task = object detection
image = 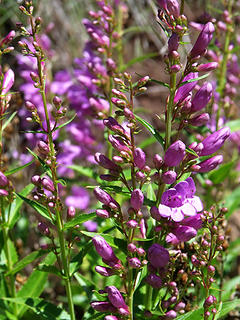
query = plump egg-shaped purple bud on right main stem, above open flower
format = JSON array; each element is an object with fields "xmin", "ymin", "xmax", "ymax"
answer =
[{"xmin": 164, "ymin": 140, "xmax": 186, "ymax": 167}]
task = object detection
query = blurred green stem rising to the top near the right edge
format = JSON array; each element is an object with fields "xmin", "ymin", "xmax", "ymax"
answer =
[{"xmin": 216, "ymin": 0, "xmax": 233, "ymax": 130}]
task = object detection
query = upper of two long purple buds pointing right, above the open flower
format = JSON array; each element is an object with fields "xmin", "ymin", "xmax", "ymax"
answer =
[{"xmin": 200, "ymin": 127, "xmax": 231, "ymax": 156}]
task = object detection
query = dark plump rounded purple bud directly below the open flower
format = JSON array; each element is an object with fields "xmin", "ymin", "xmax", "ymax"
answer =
[{"xmin": 148, "ymin": 243, "xmax": 169, "ymax": 268}]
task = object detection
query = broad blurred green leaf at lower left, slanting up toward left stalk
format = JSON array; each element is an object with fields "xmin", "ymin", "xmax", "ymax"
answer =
[{"xmin": 17, "ymin": 252, "xmax": 56, "ymax": 318}]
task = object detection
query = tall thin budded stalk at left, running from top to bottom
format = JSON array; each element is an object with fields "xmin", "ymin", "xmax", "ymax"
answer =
[{"xmin": 20, "ymin": 2, "xmax": 75, "ymax": 320}]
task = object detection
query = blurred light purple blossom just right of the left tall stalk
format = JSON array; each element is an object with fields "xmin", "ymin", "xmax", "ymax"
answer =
[{"xmin": 65, "ymin": 185, "xmax": 90, "ymax": 210}]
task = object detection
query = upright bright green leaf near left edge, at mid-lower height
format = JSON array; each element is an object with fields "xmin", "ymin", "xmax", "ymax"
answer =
[{"xmin": 6, "ymin": 183, "xmax": 34, "ymax": 229}]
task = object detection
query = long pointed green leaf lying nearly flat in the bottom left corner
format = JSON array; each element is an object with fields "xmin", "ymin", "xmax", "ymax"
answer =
[{"xmin": 2, "ymin": 297, "xmax": 70, "ymax": 320}]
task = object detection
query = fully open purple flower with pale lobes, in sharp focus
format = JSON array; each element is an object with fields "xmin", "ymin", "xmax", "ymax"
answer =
[{"xmin": 158, "ymin": 177, "xmax": 203, "ymax": 222}]
